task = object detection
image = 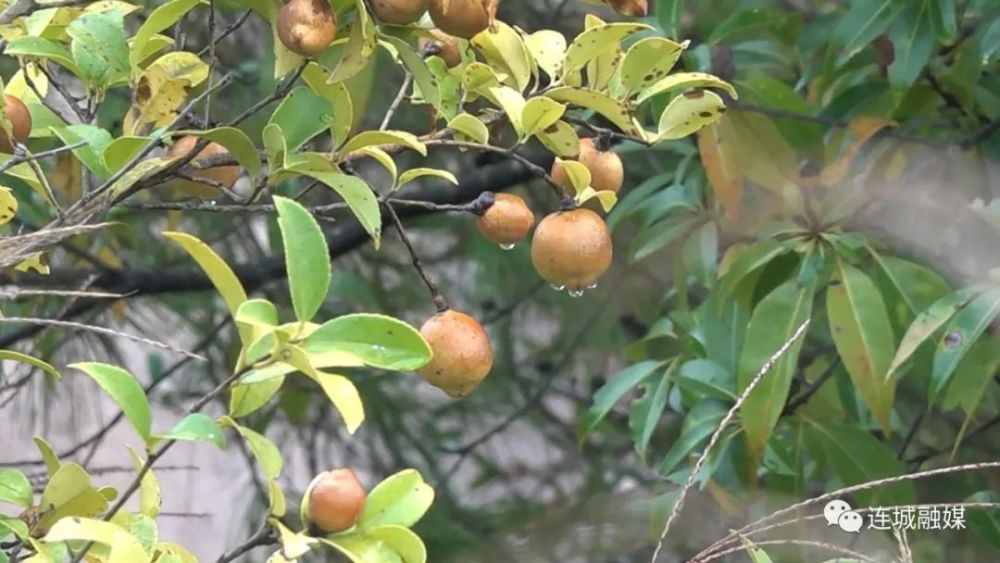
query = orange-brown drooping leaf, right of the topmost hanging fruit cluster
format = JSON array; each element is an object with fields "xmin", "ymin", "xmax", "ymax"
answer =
[{"xmin": 698, "ymin": 118, "xmax": 743, "ymax": 220}]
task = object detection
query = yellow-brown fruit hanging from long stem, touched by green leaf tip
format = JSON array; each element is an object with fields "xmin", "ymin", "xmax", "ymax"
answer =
[{"xmin": 419, "ymin": 310, "xmax": 493, "ymax": 399}]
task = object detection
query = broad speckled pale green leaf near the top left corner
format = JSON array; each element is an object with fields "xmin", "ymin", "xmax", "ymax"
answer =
[{"xmin": 66, "ymin": 12, "xmax": 130, "ymax": 90}]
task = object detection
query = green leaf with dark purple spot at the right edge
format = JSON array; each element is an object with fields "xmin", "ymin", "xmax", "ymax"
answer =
[{"xmin": 928, "ymin": 290, "xmax": 1000, "ymax": 404}]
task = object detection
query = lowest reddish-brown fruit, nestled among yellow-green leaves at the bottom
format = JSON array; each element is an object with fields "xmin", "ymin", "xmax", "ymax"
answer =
[{"xmin": 308, "ymin": 467, "xmax": 366, "ymax": 534}]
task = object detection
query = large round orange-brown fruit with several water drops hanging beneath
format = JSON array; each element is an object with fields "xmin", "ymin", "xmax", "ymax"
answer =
[{"xmin": 531, "ymin": 208, "xmax": 612, "ymax": 292}]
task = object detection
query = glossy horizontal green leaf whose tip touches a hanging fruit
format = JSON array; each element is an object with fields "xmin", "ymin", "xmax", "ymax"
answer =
[{"xmin": 303, "ymin": 313, "xmax": 431, "ymax": 371}]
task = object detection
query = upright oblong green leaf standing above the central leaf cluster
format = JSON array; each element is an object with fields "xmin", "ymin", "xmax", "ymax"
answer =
[{"xmin": 274, "ymin": 196, "xmax": 330, "ymax": 321}]
